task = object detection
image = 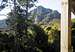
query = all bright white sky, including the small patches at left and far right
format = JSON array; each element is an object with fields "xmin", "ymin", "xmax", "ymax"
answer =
[{"xmin": 0, "ymin": 0, "xmax": 75, "ymax": 20}]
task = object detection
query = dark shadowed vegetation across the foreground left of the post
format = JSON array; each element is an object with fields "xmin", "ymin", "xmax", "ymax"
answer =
[{"xmin": 0, "ymin": 22, "xmax": 59, "ymax": 52}]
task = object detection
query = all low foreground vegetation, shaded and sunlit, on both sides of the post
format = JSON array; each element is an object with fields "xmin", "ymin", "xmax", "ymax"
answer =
[{"xmin": 0, "ymin": 18, "xmax": 75, "ymax": 52}]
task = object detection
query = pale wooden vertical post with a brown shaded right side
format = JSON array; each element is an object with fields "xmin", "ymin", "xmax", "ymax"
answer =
[{"xmin": 60, "ymin": 0, "xmax": 72, "ymax": 52}]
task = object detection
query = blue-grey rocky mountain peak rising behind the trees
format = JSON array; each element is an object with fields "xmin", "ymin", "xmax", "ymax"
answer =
[{"xmin": 30, "ymin": 6, "xmax": 61, "ymax": 23}]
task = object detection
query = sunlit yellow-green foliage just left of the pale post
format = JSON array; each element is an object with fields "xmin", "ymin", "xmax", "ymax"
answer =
[{"xmin": 44, "ymin": 22, "xmax": 59, "ymax": 43}]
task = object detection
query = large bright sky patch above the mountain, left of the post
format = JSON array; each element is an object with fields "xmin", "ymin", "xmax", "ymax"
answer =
[{"xmin": 37, "ymin": 0, "xmax": 61, "ymax": 12}]
